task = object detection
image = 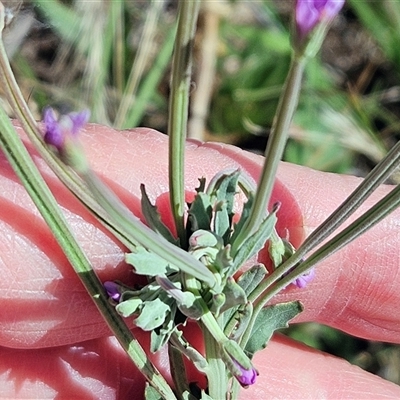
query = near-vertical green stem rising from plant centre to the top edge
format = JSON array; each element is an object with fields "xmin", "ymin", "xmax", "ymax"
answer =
[{"xmin": 168, "ymin": 0, "xmax": 200, "ymax": 246}]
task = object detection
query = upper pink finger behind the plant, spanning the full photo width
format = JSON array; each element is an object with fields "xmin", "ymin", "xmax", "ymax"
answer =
[{"xmin": 0, "ymin": 125, "xmax": 400, "ymax": 347}]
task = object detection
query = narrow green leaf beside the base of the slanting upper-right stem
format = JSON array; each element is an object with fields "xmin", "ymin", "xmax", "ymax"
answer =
[{"xmin": 230, "ymin": 213, "xmax": 277, "ymax": 275}]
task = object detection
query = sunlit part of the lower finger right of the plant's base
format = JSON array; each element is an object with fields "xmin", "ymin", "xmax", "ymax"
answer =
[{"xmin": 241, "ymin": 336, "xmax": 400, "ymax": 399}]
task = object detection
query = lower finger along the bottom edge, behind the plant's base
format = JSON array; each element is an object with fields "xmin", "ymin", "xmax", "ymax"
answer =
[{"xmin": 0, "ymin": 336, "xmax": 400, "ymax": 400}]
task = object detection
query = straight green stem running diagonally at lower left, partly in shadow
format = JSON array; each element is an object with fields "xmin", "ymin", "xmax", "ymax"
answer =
[{"xmin": 0, "ymin": 107, "xmax": 175, "ymax": 399}]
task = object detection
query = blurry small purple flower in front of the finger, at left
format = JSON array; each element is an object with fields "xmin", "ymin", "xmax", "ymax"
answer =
[{"xmin": 43, "ymin": 107, "xmax": 90, "ymax": 152}]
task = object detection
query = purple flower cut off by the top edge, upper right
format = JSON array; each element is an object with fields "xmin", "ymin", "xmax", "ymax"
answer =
[{"xmin": 296, "ymin": 0, "xmax": 345, "ymax": 42}]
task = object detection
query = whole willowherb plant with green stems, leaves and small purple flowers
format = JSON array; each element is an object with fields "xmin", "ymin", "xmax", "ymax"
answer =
[{"xmin": 0, "ymin": 0, "xmax": 400, "ymax": 400}]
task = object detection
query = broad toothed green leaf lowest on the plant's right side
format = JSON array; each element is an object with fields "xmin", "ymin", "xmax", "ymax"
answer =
[{"xmin": 245, "ymin": 301, "xmax": 303, "ymax": 358}]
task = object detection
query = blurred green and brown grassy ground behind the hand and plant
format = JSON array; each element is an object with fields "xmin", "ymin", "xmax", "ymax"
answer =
[{"xmin": 0, "ymin": 0, "xmax": 400, "ymax": 384}]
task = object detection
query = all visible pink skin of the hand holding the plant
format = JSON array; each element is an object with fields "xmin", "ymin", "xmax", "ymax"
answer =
[{"xmin": 0, "ymin": 125, "xmax": 400, "ymax": 399}]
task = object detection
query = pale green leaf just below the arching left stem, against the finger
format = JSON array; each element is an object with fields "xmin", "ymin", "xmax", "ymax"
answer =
[{"xmin": 125, "ymin": 246, "xmax": 177, "ymax": 276}]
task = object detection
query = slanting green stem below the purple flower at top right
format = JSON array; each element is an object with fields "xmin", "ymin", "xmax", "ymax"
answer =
[{"xmin": 232, "ymin": 57, "xmax": 306, "ymax": 255}]
